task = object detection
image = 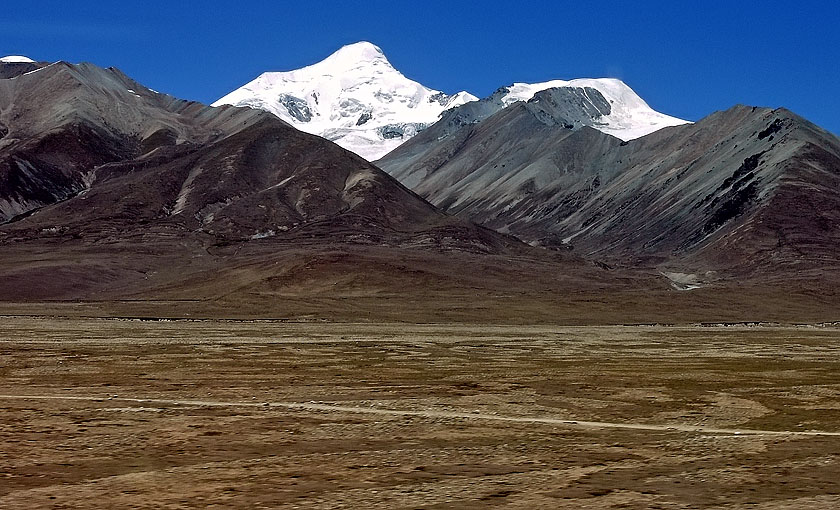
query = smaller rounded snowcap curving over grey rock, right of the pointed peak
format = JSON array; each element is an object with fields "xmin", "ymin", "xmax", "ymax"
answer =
[{"xmin": 502, "ymin": 78, "xmax": 689, "ymax": 141}]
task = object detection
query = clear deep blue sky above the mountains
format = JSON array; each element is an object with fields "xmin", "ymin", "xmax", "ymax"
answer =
[{"xmin": 0, "ymin": 0, "xmax": 840, "ymax": 133}]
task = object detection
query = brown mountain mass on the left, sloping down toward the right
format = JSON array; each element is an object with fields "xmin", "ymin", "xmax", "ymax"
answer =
[{"xmin": 0, "ymin": 57, "xmax": 624, "ymax": 306}]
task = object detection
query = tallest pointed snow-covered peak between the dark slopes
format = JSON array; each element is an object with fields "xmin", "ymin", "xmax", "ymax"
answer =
[{"xmin": 213, "ymin": 42, "xmax": 477, "ymax": 161}]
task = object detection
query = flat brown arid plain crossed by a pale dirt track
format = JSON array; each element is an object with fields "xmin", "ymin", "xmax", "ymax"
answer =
[{"xmin": 0, "ymin": 317, "xmax": 840, "ymax": 509}]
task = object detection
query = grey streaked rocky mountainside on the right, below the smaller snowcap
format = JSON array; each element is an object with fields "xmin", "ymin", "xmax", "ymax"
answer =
[{"xmin": 378, "ymin": 88, "xmax": 840, "ymax": 278}]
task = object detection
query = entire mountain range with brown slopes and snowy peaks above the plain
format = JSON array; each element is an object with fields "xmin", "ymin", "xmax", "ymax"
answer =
[{"xmin": 0, "ymin": 43, "xmax": 840, "ymax": 322}]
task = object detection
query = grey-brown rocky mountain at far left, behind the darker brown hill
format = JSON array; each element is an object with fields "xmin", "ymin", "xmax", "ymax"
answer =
[{"xmin": 0, "ymin": 62, "xmax": 266, "ymax": 221}]
